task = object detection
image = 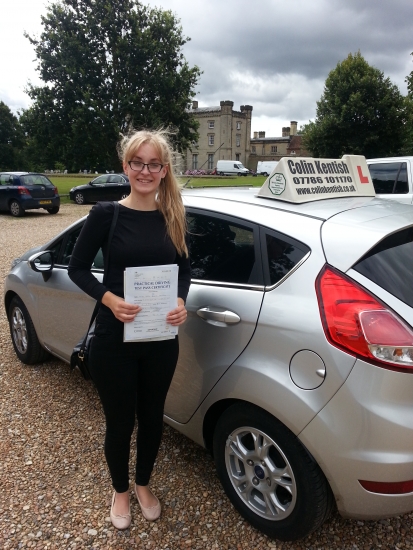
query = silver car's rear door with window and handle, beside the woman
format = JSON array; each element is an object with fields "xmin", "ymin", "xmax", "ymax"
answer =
[{"xmin": 165, "ymin": 210, "xmax": 264, "ymax": 423}]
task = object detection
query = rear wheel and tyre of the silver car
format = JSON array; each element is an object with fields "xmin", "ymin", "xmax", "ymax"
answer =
[{"xmin": 213, "ymin": 403, "xmax": 334, "ymax": 541}]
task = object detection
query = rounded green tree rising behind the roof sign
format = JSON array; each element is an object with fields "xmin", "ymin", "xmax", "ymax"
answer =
[{"xmin": 303, "ymin": 52, "xmax": 406, "ymax": 158}]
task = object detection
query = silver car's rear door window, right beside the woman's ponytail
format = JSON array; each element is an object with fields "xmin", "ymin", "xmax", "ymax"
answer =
[{"xmin": 187, "ymin": 213, "xmax": 255, "ymax": 284}]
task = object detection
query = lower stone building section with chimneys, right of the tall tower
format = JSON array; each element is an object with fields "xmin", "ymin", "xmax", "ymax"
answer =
[{"xmin": 246, "ymin": 120, "xmax": 310, "ymax": 170}]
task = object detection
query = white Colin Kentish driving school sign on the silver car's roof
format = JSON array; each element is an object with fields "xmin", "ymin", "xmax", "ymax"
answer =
[{"xmin": 257, "ymin": 155, "xmax": 376, "ymax": 203}]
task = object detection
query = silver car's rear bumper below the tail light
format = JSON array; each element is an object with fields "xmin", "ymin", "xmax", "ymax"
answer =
[{"xmin": 299, "ymin": 360, "xmax": 413, "ymax": 519}]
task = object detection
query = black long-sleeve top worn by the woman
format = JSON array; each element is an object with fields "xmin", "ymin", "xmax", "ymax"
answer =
[{"xmin": 68, "ymin": 202, "xmax": 191, "ymax": 301}]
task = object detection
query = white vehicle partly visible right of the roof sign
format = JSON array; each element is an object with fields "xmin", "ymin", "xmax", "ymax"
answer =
[{"xmin": 367, "ymin": 157, "xmax": 413, "ymax": 204}]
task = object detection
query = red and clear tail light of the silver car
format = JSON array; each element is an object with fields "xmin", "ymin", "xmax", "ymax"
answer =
[{"xmin": 316, "ymin": 266, "xmax": 413, "ymax": 373}]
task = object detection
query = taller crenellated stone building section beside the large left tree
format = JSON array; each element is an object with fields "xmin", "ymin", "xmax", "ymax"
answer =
[{"xmin": 186, "ymin": 101, "xmax": 252, "ymax": 170}]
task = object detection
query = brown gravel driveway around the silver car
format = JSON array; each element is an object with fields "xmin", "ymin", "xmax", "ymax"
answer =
[{"xmin": 0, "ymin": 205, "xmax": 413, "ymax": 550}]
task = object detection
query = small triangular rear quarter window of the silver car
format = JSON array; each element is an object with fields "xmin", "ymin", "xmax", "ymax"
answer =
[{"xmin": 262, "ymin": 230, "xmax": 310, "ymax": 285}]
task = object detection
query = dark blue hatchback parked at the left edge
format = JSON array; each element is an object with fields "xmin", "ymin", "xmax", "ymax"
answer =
[{"xmin": 0, "ymin": 172, "xmax": 60, "ymax": 217}]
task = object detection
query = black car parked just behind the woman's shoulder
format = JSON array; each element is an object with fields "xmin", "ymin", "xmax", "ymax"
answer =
[{"xmin": 69, "ymin": 174, "xmax": 130, "ymax": 204}]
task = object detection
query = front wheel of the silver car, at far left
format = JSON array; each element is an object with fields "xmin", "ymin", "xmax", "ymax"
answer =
[{"xmin": 8, "ymin": 296, "xmax": 49, "ymax": 365}]
